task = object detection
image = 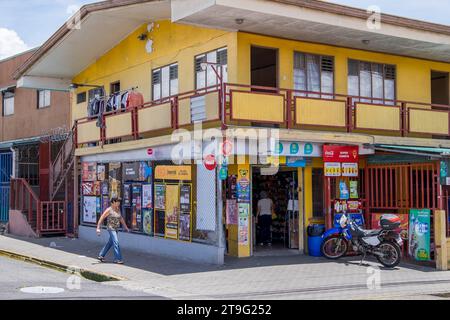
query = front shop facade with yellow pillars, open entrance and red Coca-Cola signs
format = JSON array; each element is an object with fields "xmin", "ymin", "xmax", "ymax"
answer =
[{"xmin": 224, "ymin": 141, "xmax": 375, "ymax": 257}]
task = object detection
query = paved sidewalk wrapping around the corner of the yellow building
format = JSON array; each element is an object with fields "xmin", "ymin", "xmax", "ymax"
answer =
[{"xmin": 0, "ymin": 236, "xmax": 450, "ymax": 299}]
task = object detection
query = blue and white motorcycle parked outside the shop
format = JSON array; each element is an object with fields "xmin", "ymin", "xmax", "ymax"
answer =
[{"xmin": 321, "ymin": 213, "xmax": 403, "ymax": 268}]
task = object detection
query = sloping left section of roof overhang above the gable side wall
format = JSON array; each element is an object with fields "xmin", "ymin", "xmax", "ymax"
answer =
[{"xmin": 16, "ymin": 0, "xmax": 170, "ymax": 91}]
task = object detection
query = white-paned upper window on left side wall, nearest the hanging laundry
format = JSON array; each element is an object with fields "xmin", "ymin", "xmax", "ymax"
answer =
[{"xmin": 152, "ymin": 63, "xmax": 178, "ymax": 100}]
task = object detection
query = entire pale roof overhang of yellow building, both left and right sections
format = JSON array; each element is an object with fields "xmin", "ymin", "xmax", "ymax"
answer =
[{"xmin": 15, "ymin": 0, "xmax": 450, "ymax": 90}]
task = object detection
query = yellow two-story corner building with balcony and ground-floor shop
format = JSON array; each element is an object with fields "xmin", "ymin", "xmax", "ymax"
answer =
[{"xmin": 16, "ymin": 0, "xmax": 450, "ymax": 264}]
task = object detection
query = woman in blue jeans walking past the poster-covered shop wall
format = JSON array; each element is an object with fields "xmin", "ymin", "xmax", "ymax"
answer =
[{"xmin": 97, "ymin": 198, "xmax": 130, "ymax": 264}]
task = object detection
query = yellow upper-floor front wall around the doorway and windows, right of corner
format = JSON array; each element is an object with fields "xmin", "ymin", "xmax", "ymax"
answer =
[{"xmin": 238, "ymin": 33, "xmax": 450, "ymax": 103}]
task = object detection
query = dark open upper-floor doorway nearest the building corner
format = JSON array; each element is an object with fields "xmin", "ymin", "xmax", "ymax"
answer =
[{"xmin": 251, "ymin": 46, "xmax": 278, "ymax": 91}]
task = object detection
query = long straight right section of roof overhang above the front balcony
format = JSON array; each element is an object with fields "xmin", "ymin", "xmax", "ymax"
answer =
[{"xmin": 172, "ymin": 0, "xmax": 450, "ymax": 62}]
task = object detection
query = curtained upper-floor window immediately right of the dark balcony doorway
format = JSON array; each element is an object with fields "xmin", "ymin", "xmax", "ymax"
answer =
[{"xmin": 294, "ymin": 52, "xmax": 334, "ymax": 98}]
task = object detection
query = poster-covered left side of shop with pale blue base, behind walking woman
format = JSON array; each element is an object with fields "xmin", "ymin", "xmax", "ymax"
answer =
[{"xmin": 79, "ymin": 141, "xmax": 224, "ymax": 264}]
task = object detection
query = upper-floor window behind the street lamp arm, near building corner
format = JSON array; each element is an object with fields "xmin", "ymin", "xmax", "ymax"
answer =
[{"xmin": 195, "ymin": 48, "xmax": 228, "ymax": 89}]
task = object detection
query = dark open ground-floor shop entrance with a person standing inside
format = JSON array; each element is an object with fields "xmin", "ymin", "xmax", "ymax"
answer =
[{"xmin": 252, "ymin": 167, "xmax": 299, "ymax": 255}]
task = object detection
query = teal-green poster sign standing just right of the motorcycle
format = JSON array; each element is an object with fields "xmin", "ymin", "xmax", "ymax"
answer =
[{"xmin": 408, "ymin": 209, "xmax": 431, "ymax": 261}]
